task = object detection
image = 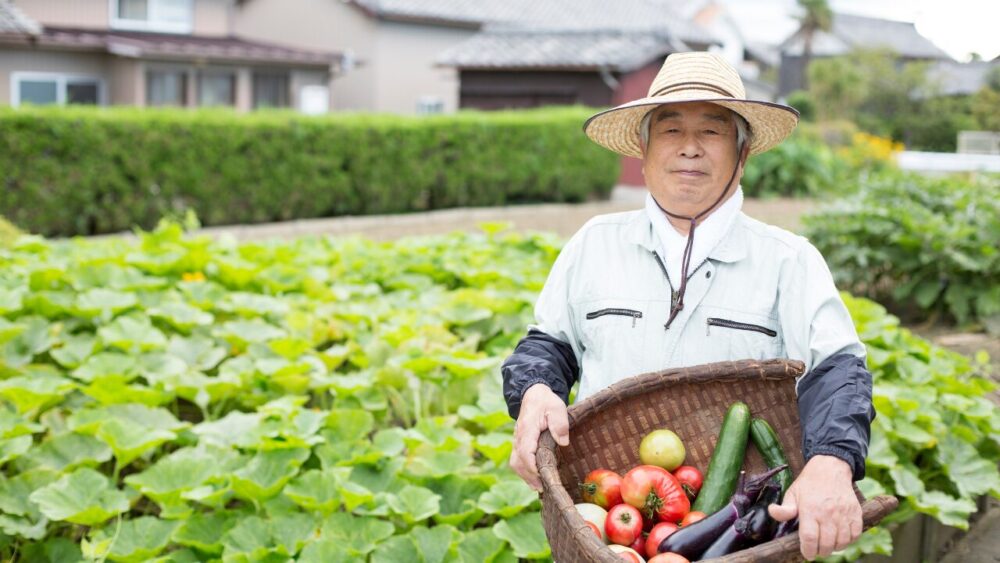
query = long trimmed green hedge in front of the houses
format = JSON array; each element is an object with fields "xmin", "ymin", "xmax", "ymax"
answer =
[{"xmin": 0, "ymin": 107, "xmax": 619, "ymax": 236}]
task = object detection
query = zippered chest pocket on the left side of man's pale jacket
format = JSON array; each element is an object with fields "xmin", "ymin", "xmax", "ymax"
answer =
[{"xmin": 578, "ymin": 299, "xmax": 649, "ymax": 373}]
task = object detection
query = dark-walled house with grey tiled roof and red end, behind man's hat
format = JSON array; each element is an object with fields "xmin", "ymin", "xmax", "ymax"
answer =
[{"xmin": 437, "ymin": 0, "xmax": 719, "ymax": 186}]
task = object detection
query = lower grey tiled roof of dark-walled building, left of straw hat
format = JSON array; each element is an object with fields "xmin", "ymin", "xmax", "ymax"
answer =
[{"xmin": 438, "ymin": 30, "xmax": 686, "ymax": 71}]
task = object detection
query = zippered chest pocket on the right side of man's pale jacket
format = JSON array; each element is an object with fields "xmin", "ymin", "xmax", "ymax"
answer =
[{"xmin": 690, "ymin": 308, "xmax": 784, "ymax": 363}]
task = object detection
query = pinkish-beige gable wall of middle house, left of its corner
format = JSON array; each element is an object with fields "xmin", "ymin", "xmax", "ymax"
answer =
[{"xmin": 234, "ymin": 0, "xmax": 376, "ymax": 110}]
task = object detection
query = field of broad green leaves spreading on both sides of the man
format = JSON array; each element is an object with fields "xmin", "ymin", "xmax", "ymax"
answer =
[{"xmin": 0, "ymin": 223, "xmax": 1000, "ymax": 562}]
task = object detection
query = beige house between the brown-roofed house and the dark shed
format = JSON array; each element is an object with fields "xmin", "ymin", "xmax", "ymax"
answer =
[{"xmin": 234, "ymin": 0, "xmax": 534, "ymax": 114}]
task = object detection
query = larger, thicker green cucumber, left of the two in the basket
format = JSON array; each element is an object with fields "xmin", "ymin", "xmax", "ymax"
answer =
[{"xmin": 691, "ymin": 402, "xmax": 750, "ymax": 514}]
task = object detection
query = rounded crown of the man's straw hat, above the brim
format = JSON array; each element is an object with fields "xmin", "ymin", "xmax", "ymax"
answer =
[{"xmin": 648, "ymin": 52, "xmax": 746, "ymax": 101}]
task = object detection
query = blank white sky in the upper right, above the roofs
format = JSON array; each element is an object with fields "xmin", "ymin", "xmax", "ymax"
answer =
[{"xmin": 723, "ymin": 0, "xmax": 1000, "ymax": 61}]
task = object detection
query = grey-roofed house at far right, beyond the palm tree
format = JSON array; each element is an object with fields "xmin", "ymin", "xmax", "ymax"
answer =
[{"xmin": 778, "ymin": 13, "xmax": 953, "ymax": 96}]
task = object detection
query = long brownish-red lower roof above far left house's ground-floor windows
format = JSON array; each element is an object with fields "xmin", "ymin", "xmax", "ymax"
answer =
[{"xmin": 8, "ymin": 26, "xmax": 341, "ymax": 65}]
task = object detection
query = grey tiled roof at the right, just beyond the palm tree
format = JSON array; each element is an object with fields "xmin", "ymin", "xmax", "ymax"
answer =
[{"xmin": 782, "ymin": 14, "xmax": 951, "ymax": 60}]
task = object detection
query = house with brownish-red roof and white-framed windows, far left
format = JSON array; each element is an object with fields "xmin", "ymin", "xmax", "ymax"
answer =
[{"xmin": 0, "ymin": 0, "xmax": 343, "ymax": 112}]
